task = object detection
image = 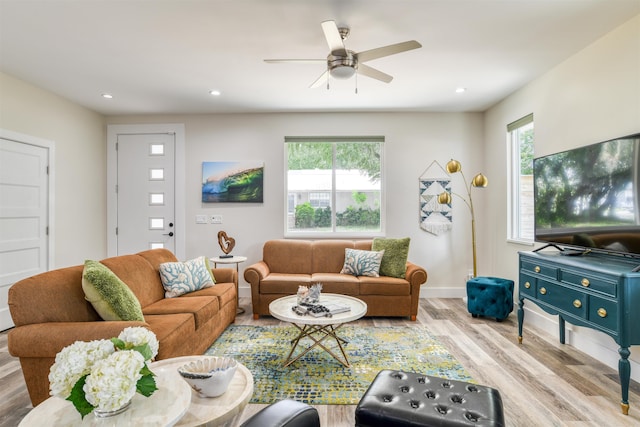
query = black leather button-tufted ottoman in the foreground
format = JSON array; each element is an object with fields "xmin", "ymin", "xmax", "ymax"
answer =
[{"xmin": 356, "ymin": 370, "xmax": 505, "ymax": 427}]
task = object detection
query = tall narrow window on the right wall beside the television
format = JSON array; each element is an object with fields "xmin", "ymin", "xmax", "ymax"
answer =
[{"xmin": 507, "ymin": 114, "xmax": 534, "ymax": 243}]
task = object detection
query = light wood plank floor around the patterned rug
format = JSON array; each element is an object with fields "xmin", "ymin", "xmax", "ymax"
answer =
[{"xmin": 0, "ymin": 298, "xmax": 640, "ymax": 427}]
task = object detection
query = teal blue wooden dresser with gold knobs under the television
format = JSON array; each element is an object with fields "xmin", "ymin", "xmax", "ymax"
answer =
[{"xmin": 518, "ymin": 251, "xmax": 640, "ymax": 414}]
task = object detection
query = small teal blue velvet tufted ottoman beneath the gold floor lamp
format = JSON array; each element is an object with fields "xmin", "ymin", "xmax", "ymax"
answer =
[{"xmin": 467, "ymin": 277, "xmax": 513, "ymax": 321}]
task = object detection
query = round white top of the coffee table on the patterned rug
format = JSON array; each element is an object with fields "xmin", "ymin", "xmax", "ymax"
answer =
[{"xmin": 269, "ymin": 293, "xmax": 367, "ymax": 325}]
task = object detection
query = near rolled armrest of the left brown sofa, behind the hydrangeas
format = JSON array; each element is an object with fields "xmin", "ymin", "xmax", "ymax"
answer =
[{"xmin": 7, "ymin": 321, "xmax": 149, "ymax": 357}]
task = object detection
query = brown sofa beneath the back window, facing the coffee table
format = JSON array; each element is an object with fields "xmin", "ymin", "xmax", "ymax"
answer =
[{"xmin": 244, "ymin": 239, "xmax": 427, "ymax": 320}]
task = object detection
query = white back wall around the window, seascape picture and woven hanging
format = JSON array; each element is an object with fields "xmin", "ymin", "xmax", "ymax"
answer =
[{"xmin": 107, "ymin": 113, "xmax": 483, "ymax": 295}]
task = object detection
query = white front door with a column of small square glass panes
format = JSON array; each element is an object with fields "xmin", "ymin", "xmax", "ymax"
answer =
[{"xmin": 116, "ymin": 133, "xmax": 176, "ymax": 255}]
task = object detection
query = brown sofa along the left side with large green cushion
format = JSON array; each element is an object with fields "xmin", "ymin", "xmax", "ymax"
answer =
[{"xmin": 8, "ymin": 249, "xmax": 238, "ymax": 406}]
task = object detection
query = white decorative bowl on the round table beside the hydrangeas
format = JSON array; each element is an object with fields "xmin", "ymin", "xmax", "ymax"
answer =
[{"xmin": 178, "ymin": 356, "xmax": 238, "ymax": 397}]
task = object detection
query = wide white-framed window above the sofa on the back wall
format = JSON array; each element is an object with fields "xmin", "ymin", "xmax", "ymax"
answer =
[{"xmin": 284, "ymin": 136, "xmax": 384, "ymax": 237}]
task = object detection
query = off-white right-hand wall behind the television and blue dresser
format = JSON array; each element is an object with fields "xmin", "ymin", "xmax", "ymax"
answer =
[{"xmin": 480, "ymin": 15, "xmax": 640, "ymax": 381}]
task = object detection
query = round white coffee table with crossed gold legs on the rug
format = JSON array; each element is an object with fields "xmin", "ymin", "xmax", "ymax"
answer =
[{"xmin": 269, "ymin": 293, "xmax": 367, "ymax": 368}]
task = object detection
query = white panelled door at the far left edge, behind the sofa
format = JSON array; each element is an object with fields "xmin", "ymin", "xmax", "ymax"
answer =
[{"xmin": 0, "ymin": 138, "xmax": 50, "ymax": 330}]
